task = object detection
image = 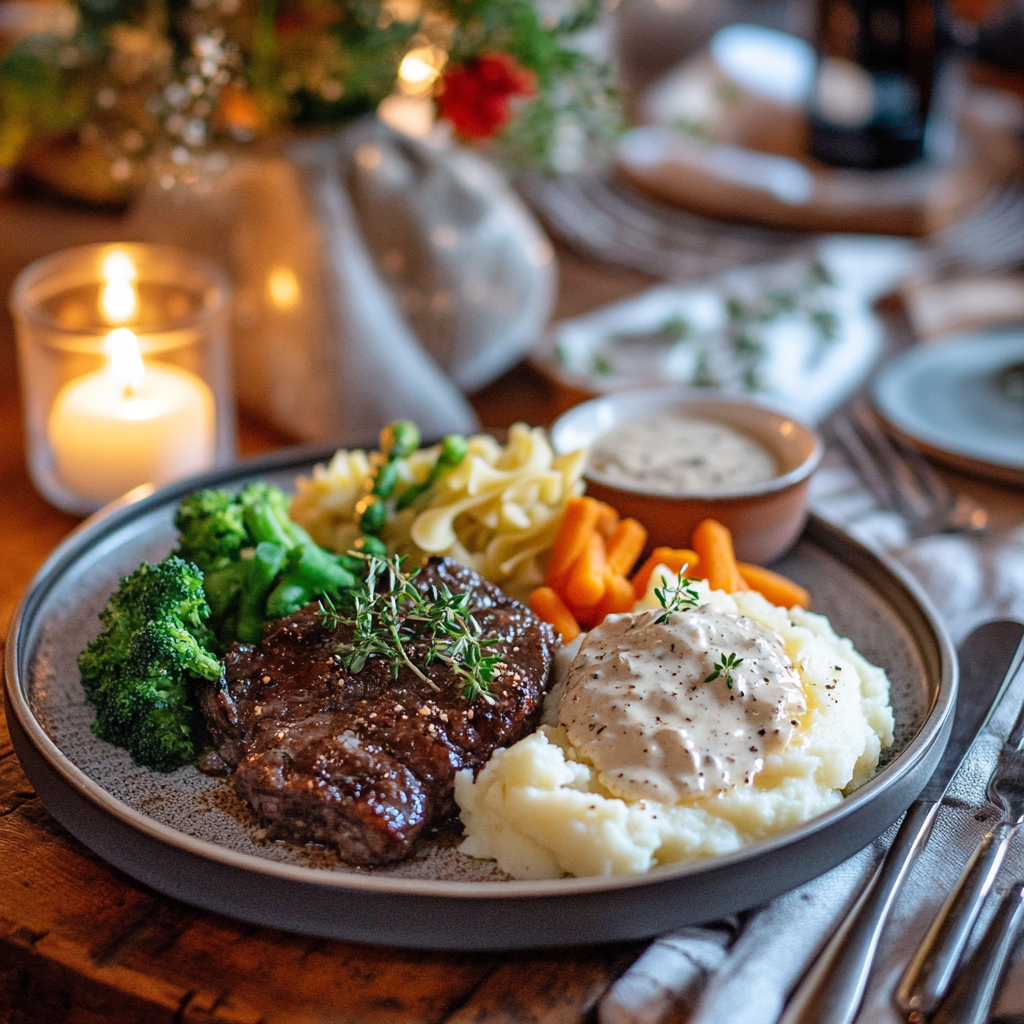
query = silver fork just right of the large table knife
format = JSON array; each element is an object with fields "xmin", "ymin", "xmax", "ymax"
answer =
[{"xmin": 895, "ymin": 630, "xmax": 1024, "ymax": 1017}]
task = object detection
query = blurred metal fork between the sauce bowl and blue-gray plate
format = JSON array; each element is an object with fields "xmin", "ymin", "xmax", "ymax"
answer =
[{"xmin": 831, "ymin": 401, "xmax": 988, "ymax": 537}]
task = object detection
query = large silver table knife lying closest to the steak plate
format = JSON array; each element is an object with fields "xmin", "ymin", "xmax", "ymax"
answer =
[{"xmin": 779, "ymin": 622, "xmax": 1024, "ymax": 1024}]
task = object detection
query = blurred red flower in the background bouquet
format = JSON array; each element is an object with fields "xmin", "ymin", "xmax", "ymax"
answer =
[{"xmin": 437, "ymin": 53, "xmax": 537, "ymax": 139}]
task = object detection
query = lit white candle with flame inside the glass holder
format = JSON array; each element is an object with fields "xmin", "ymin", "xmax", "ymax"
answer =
[{"xmin": 47, "ymin": 328, "xmax": 215, "ymax": 502}]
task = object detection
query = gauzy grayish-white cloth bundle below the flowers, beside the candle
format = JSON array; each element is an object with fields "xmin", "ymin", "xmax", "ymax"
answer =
[{"xmin": 125, "ymin": 117, "xmax": 557, "ymax": 445}]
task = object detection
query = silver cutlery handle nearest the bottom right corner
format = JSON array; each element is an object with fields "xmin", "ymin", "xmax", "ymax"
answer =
[{"xmin": 932, "ymin": 880, "xmax": 1024, "ymax": 1024}]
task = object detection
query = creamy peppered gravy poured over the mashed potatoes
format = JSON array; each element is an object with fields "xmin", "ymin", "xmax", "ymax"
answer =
[{"xmin": 558, "ymin": 605, "xmax": 807, "ymax": 803}]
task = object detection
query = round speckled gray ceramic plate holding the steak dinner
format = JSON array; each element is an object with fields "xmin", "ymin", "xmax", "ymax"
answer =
[{"xmin": 5, "ymin": 450, "xmax": 956, "ymax": 949}]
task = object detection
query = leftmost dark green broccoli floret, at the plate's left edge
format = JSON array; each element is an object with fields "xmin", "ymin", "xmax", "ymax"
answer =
[{"xmin": 78, "ymin": 555, "xmax": 221, "ymax": 771}]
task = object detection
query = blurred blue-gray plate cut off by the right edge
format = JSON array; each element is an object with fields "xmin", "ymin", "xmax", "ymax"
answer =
[{"xmin": 874, "ymin": 328, "xmax": 1024, "ymax": 486}]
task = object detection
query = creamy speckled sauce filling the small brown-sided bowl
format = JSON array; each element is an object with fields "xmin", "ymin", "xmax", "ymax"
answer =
[{"xmin": 589, "ymin": 415, "xmax": 778, "ymax": 495}]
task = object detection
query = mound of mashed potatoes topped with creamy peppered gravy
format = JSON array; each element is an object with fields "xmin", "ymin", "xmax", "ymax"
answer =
[{"xmin": 455, "ymin": 570, "xmax": 893, "ymax": 879}]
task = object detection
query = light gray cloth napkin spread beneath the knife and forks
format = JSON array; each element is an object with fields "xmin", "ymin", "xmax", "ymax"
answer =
[{"xmin": 598, "ymin": 456, "xmax": 1024, "ymax": 1024}]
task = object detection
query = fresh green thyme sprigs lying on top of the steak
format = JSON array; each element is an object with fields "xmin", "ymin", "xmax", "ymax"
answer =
[{"xmin": 321, "ymin": 552, "xmax": 501, "ymax": 703}]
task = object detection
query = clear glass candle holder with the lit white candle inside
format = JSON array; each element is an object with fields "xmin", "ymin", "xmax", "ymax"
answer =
[{"xmin": 10, "ymin": 243, "xmax": 236, "ymax": 515}]
